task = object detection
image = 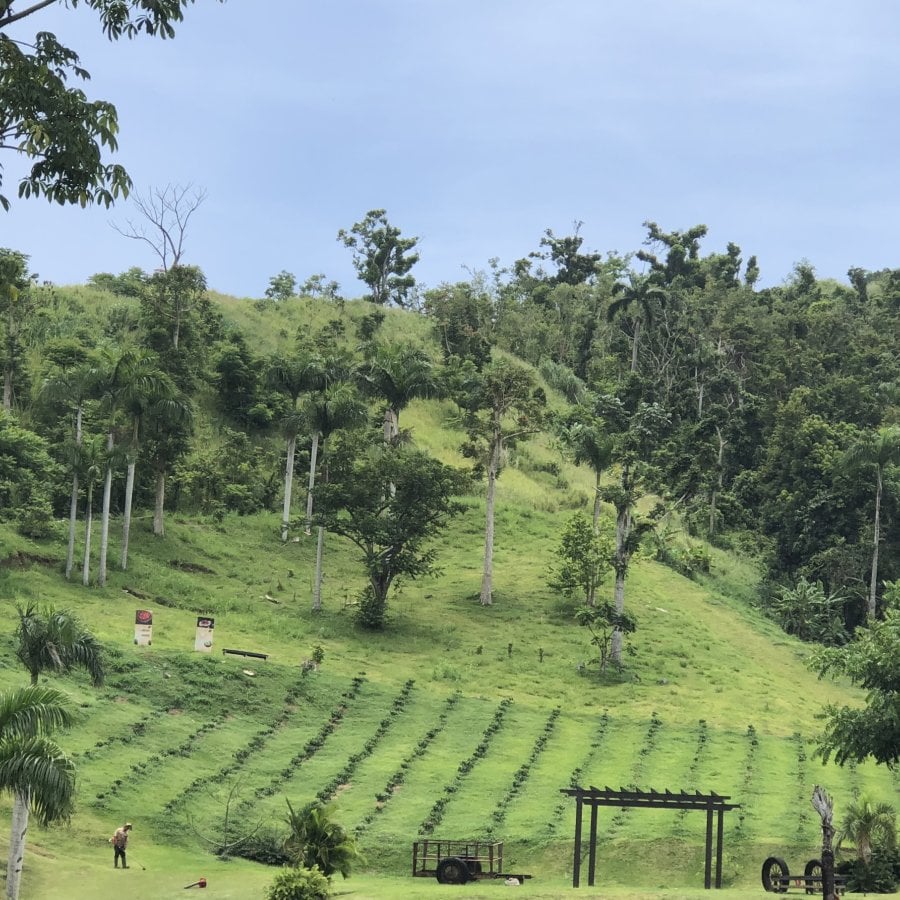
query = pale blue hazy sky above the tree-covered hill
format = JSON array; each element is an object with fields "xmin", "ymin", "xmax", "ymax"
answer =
[{"xmin": 0, "ymin": 0, "xmax": 900, "ymax": 297}]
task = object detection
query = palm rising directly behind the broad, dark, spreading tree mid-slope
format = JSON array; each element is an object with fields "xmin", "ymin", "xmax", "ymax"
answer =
[{"xmin": 362, "ymin": 343, "xmax": 438, "ymax": 444}]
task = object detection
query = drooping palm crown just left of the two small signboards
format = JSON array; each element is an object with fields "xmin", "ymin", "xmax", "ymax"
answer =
[{"xmin": 16, "ymin": 603, "xmax": 103, "ymax": 687}]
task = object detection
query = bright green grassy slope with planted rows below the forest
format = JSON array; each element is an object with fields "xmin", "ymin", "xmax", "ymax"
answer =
[{"xmin": 0, "ymin": 299, "xmax": 897, "ymax": 900}]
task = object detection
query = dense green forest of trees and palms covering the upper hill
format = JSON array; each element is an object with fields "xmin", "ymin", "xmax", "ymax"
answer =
[{"xmin": 0, "ymin": 217, "xmax": 900, "ymax": 643}]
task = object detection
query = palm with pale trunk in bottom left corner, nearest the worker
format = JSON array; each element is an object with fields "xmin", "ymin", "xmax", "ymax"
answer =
[{"xmin": 0, "ymin": 685, "xmax": 75, "ymax": 900}]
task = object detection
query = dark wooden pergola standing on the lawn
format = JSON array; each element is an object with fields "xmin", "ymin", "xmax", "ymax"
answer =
[{"xmin": 560, "ymin": 786, "xmax": 740, "ymax": 889}]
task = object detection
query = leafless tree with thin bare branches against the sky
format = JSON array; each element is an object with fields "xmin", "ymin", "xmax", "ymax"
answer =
[{"xmin": 113, "ymin": 184, "xmax": 207, "ymax": 272}]
